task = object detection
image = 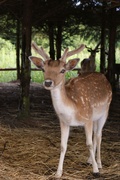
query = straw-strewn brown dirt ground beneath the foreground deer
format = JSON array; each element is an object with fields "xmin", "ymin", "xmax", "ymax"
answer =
[{"xmin": 0, "ymin": 83, "xmax": 120, "ymax": 180}]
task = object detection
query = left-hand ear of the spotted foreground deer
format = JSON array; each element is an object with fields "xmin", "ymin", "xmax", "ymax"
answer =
[{"xmin": 28, "ymin": 56, "xmax": 44, "ymax": 69}]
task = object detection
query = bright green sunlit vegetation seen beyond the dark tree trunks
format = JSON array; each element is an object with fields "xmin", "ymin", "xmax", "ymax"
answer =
[{"xmin": 0, "ymin": 33, "xmax": 120, "ymax": 83}]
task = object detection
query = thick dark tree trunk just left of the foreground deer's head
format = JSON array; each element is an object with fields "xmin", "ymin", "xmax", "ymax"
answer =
[{"xmin": 20, "ymin": 0, "xmax": 32, "ymax": 118}]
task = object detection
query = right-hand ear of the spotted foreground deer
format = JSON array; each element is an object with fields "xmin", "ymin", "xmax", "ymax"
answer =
[{"xmin": 65, "ymin": 58, "xmax": 80, "ymax": 71}]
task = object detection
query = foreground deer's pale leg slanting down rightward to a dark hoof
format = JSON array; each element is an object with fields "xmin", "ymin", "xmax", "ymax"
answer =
[{"xmin": 85, "ymin": 122, "xmax": 99, "ymax": 173}]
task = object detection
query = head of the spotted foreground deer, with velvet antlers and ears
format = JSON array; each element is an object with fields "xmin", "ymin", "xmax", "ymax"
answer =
[{"xmin": 29, "ymin": 43, "xmax": 85, "ymax": 89}]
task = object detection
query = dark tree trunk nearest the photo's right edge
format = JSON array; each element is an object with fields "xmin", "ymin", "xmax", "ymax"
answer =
[{"xmin": 108, "ymin": 8, "xmax": 116, "ymax": 88}]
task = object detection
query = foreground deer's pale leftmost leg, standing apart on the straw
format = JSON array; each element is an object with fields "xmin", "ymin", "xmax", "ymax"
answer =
[{"xmin": 55, "ymin": 121, "xmax": 70, "ymax": 178}]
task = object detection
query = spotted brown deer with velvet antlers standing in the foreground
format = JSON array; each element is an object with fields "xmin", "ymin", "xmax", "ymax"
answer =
[{"xmin": 28, "ymin": 43, "xmax": 112, "ymax": 178}]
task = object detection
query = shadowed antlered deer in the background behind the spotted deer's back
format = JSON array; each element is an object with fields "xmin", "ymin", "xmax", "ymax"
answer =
[{"xmin": 78, "ymin": 42, "xmax": 100, "ymax": 74}]
